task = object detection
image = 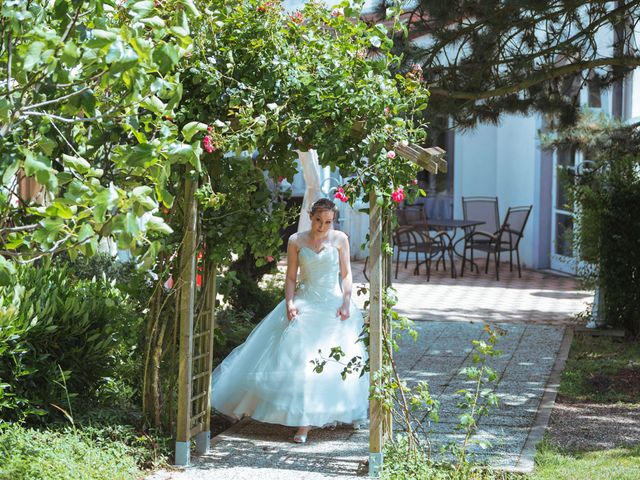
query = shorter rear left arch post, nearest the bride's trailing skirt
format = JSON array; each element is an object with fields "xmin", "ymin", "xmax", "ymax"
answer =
[{"xmin": 196, "ymin": 262, "xmax": 218, "ymax": 454}]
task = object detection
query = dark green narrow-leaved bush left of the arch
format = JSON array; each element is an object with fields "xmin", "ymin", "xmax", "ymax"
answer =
[{"xmin": 0, "ymin": 258, "xmax": 142, "ymax": 420}]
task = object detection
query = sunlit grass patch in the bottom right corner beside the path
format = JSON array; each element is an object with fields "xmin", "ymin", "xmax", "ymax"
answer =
[{"xmin": 530, "ymin": 440, "xmax": 640, "ymax": 480}]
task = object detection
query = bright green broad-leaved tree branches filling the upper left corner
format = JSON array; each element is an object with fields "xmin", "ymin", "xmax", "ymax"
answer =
[{"xmin": 0, "ymin": 0, "xmax": 199, "ymax": 270}]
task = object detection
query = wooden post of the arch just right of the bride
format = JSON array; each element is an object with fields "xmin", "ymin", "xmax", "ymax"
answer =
[{"xmin": 369, "ymin": 190, "xmax": 383, "ymax": 477}]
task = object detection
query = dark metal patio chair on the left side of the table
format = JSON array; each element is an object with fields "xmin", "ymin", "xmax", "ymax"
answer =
[{"xmin": 394, "ymin": 205, "xmax": 455, "ymax": 281}]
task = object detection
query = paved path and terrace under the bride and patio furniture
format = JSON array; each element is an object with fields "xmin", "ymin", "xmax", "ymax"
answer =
[{"xmin": 151, "ymin": 263, "xmax": 591, "ymax": 480}]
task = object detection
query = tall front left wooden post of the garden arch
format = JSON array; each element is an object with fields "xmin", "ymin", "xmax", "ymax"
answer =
[{"xmin": 175, "ymin": 179, "xmax": 198, "ymax": 465}]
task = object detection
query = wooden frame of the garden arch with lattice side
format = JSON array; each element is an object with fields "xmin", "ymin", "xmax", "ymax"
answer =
[{"xmin": 175, "ymin": 143, "xmax": 447, "ymax": 477}]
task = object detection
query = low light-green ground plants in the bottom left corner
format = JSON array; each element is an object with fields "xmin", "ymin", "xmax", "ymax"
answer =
[{"xmin": 0, "ymin": 424, "xmax": 141, "ymax": 480}]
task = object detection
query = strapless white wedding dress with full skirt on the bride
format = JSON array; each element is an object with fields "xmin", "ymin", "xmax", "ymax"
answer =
[{"xmin": 211, "ymin": 246, "xmax": 369, "ymax": 427}]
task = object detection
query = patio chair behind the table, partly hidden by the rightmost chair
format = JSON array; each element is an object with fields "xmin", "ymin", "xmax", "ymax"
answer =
[{"xmin": 460, "ymin": 197, "xmax": 500, "ymax": 276}]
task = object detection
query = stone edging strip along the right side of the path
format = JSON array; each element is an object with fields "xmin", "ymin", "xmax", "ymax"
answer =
[{"xmin": 505, "ymin": 326, "xmax": 573, "ymax": 473}]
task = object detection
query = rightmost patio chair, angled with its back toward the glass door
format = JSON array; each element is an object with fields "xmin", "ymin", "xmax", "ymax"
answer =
[{"xmin": 462, "ymin": 205, "xmax": 533, "ymax": 280}]
